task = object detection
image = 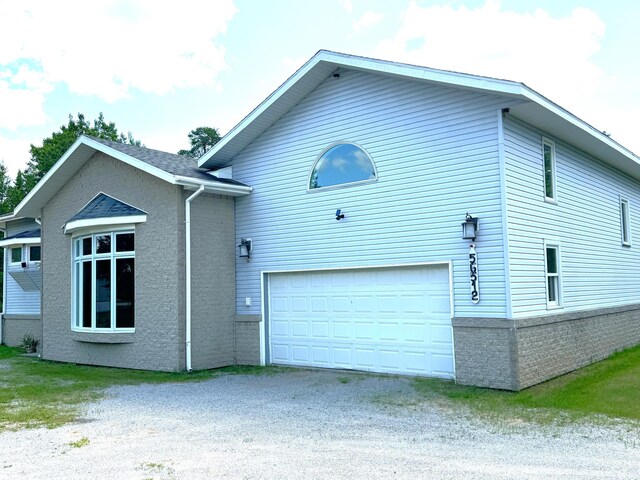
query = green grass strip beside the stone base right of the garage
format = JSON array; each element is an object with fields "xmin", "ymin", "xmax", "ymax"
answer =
[{"xmin": 415, "ymin": 346, "xmax": 640, "ymax": 421}]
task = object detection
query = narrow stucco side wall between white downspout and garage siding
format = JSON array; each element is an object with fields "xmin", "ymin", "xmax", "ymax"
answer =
[{"xmin": 189, "ymin": 192, "xmax": 236, "ymax": 369}]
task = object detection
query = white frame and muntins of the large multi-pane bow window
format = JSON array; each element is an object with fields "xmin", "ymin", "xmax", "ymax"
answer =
[{"xmin": 71, "ymin": 231, "xmax": 136, "ymax": 333}]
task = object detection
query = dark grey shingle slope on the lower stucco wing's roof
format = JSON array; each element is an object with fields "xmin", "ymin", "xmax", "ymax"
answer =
[{"xmin": 89, "ymin": 137, "xmax": 246, "ymax": 186}]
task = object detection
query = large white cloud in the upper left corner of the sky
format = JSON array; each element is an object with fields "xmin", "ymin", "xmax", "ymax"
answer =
[{"xmin": 0, "ymin": 0, "xmax": 237, "ymax": 128}]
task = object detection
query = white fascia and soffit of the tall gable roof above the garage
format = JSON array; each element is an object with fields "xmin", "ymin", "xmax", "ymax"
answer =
[{"xmin": 198, "ymin": 50, "xmax": 640, "ymax": 179}]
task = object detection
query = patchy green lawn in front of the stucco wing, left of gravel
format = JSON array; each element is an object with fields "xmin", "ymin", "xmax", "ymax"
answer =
[{"xmin": 0, "ymin": 346, "xmax": 277, "ymax": 432}]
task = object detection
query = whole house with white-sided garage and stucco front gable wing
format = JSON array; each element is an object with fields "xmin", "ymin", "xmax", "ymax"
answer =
[{"xmin": 5, "ymin": 51, "xmax": 640, "ymax": 390}]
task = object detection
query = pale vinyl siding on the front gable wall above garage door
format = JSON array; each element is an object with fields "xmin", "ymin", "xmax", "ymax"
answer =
[{"xmin": 233, "ymin": 71, "xmax": 508, "ymax": 317}]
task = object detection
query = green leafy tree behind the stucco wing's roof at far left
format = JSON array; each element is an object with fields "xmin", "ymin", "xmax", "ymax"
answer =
[{"xmin": 0, "ymin": 112, "xmax": 142, "ymax": 211}]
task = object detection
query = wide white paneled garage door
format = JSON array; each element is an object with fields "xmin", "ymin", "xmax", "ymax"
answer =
[{"xmin": 268, "ymin": 266, "xmax": 454, "ymax": 377}]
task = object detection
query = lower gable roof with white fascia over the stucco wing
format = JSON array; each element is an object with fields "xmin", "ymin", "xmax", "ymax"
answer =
[{"xmin": 13, "ymin": 135, "xmax": 251, "ymax": 218}]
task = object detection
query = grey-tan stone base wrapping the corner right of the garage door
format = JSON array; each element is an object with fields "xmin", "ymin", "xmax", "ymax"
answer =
[{"xmin": 453, "ymin": 305, "xmax": 640, "ymax": 390}]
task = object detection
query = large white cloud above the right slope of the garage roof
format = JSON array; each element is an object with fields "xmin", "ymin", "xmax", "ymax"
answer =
[{"xmin": 376, "ymin": 1, "xmax": 612, "ymax": 118}]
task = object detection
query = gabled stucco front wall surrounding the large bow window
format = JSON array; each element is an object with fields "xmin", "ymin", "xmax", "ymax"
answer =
[{"xmin": 42, "ymin": 153, "xmax": 185, "ymax": 371}]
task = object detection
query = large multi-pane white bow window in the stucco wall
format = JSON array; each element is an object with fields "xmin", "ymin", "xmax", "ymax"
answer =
[{"xmin": 73, "ymin": 231, "xmax": 135, "ymax": 332}]
